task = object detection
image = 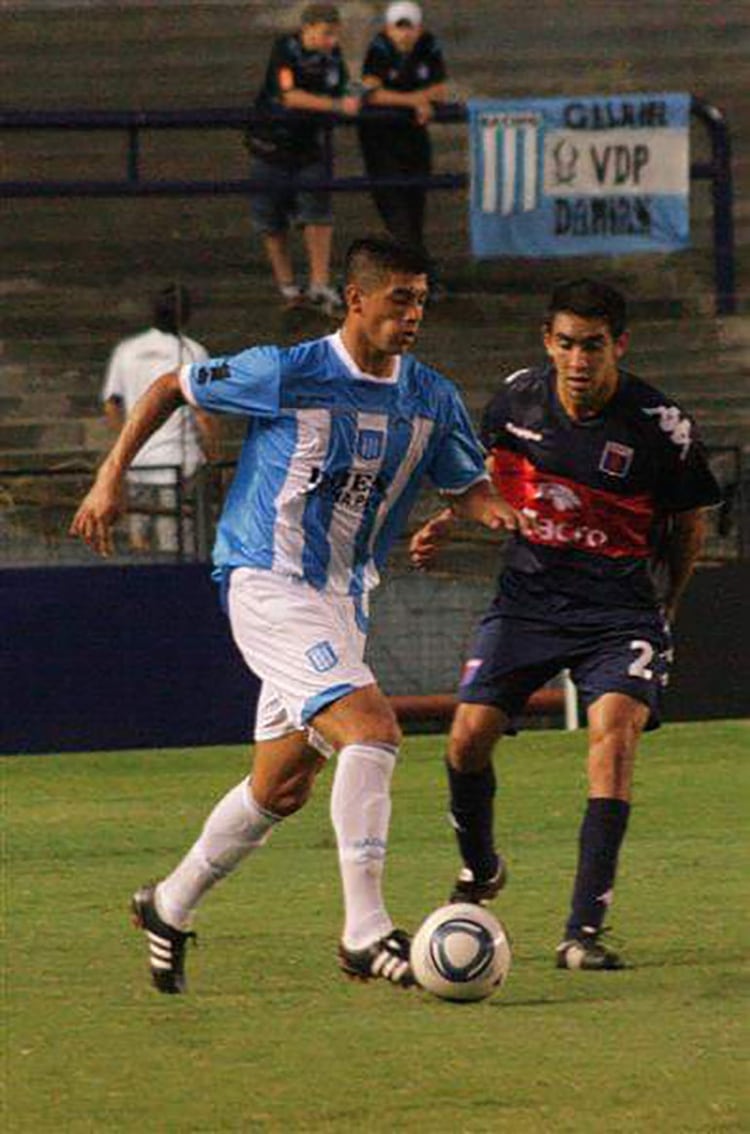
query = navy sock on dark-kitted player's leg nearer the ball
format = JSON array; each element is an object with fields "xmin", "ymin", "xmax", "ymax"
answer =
[{"xmin": 446, "ymin": 761, "xmax": 498, "ymax": 882}]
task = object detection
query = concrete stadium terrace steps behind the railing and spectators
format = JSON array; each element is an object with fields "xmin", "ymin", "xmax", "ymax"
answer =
[{"xmin": 0, "ymin": 0, "xmax": 750, "ymax": 476}]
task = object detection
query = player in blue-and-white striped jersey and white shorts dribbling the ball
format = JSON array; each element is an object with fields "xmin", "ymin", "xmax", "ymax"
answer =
[{"xmin": 71, "ymin": 238, "xmax": 526, "ymax": 993}]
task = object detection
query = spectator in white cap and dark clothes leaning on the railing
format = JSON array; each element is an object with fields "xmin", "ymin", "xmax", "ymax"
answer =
[{"xmin": 360, "ymin": 2, "xmax": 446, "ymax": 267}]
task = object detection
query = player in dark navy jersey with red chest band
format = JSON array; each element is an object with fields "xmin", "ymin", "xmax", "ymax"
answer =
[{"xmin": 412, "ymin": 279, "xmax": 719, "ymax": 970}]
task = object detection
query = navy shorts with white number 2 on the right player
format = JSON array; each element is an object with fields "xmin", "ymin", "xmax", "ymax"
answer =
[{"xmin": 458, "ymin": 604, "xmax": 673, "ymax": 728}]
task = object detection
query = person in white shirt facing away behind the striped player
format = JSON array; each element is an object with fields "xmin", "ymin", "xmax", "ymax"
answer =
[{"xmin": 102, "ymin": 285, "xmax": 216, "ymax": 553}]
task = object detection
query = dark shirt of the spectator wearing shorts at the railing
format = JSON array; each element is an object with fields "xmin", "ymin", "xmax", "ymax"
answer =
[{"xmin": 247, "ymin": 32, "xmax": 348, "ymax": 167}]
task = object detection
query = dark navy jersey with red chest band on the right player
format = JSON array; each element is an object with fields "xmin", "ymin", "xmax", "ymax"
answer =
[{"xmin": 480, "ymin": 366, "xmax": 720, "ymax": 618}]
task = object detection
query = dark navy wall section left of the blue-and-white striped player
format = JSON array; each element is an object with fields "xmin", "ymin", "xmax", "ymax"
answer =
[{"xmin": 0, "ymin": 565, "xmax": 256, "ymax": 753}]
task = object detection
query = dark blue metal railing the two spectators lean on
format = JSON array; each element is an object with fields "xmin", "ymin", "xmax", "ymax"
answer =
[{"xmin": 0, "ymin": 96, "xmax": 736, "ymax": 315}]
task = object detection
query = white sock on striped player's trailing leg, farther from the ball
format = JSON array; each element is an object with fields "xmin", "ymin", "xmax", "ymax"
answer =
[{"xmin": 155, "ymin": 778, "xmax": 279, "ymax": 929}]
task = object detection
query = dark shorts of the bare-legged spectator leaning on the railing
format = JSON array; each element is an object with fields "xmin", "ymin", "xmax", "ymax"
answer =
[{"xmin": 250, "ymin": 158, "xmax": 334, "ymax": 236}]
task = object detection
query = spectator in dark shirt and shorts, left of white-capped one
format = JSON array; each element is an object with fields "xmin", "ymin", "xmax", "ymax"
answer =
[{"xmin": 247, "ymin": 3, "xmax": 360, "ymax": 314}]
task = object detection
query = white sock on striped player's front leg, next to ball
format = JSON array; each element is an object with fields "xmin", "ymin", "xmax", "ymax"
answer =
[{"xmin": 330, "ymin": 744, "xmax": 397, "ymax": 949}]
